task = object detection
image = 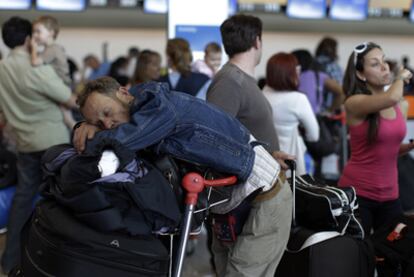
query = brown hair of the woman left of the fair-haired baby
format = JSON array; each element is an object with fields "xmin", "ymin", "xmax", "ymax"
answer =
[{"xmin": 167, "ymin": 38, "xmax": 193, "ymax": 76}]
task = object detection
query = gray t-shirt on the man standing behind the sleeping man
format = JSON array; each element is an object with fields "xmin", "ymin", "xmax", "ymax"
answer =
[{"xmin": 207, "ymin": 62, "xmax": 279, "ymax": 152}]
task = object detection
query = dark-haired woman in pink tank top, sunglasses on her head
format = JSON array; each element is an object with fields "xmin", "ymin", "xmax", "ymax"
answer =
[{"xmin": 339, "ymin": 42, "xmax": 414, "ymax": 234}]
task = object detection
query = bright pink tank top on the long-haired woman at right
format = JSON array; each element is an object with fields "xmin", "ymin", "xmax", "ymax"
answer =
[{"xmin": 339, "ymin": 106, "xmax": 407, "ymax": 202}]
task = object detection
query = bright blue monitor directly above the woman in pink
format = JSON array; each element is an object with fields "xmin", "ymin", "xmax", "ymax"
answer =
[{"xmin": 329, "ymin": 0, "xmax": 368, "ymax": 21}]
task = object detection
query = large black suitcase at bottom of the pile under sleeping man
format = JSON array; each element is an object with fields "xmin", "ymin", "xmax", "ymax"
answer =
[{"xmin": 21, "ymin": 200, "xmax": 169, "ymax": 277}]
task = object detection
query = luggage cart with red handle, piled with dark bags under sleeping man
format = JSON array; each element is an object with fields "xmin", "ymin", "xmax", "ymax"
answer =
[{"xmin": 18, "ymin": 142, "xmax": 237, "ymax": 277}]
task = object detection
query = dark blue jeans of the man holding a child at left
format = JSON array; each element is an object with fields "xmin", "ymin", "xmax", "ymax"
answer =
[{"xmin": 1, "ymin": 151, "xmax": 44, "ymax": 272}]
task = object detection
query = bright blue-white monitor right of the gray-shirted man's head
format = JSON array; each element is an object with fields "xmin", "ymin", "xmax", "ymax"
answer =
[{"xmin": 286, "ymin": 0, "xmax": 326, "ymax": 19}]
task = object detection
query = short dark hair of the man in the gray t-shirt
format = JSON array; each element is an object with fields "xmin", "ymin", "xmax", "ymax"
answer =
[{"xmin": 220, "ymin": 14, "xmax": 262, "ymax": 58}]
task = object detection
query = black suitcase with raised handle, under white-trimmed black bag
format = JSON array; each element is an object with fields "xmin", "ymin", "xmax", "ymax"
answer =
[{"xmin": 275, "ymin": 161, "xmax": 375, "ymax": 277}]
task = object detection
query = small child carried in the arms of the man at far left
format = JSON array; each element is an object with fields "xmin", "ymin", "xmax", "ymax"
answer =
[{"xmin": 31, "ymin": 15, "xmax": 76, "ymax": 129}]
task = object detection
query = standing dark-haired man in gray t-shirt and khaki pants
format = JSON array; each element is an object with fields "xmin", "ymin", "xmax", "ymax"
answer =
[{"xmin": 207, "ymin": 15, "xmax": 294, "ymax": 277}]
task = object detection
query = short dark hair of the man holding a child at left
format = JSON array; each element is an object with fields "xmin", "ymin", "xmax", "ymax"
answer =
[{"xmin": 1, "ymin": 16, "xmax": 32, "ymax": 49}]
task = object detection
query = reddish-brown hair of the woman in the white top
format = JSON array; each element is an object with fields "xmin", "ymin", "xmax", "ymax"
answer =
[{"xmin": 266, "ymin": 52, "xmax": 298, "ymax": 91}]
